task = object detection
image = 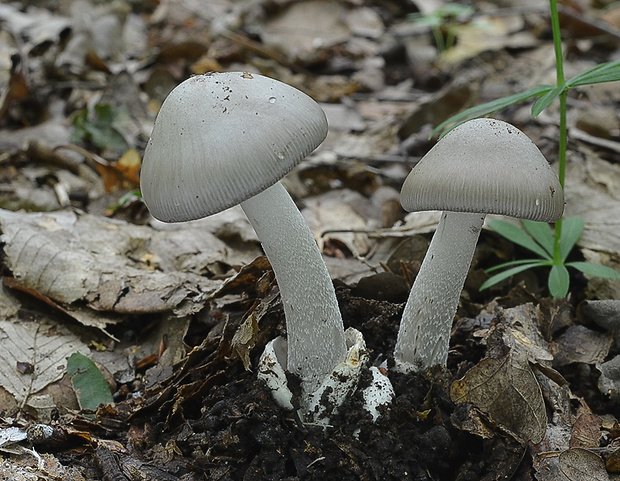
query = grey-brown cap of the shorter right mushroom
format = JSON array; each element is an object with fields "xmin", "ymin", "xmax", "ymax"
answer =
[{"xmin": 400, "ymin": 119, "xmax": 564, "ymax": 222}]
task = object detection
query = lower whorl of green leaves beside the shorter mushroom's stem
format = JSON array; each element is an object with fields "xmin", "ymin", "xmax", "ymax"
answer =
[{"xmin": 480, "ymin": 217, "xmax": 620, "ymax": 297}]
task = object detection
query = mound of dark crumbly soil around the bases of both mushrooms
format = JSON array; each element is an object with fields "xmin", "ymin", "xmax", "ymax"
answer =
[{"xmin": 132, "ymin": 286, "xmax": 524, "ymax": 481}]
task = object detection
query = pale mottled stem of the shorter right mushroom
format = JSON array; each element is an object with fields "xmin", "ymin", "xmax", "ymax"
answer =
[{"xmin": 394, "ymin": 211, "xmax": 485, "ymax": 371}]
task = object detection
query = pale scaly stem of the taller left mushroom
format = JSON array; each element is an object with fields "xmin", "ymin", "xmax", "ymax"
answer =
[{"xmin": 241, "ymin": 182, "xmax": 347, "ymax": 394}]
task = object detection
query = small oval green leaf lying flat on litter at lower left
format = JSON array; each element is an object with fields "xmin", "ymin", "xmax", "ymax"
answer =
[{"xmin": 67, "ymin": 352, "xmax": 113, "ymax": 411}]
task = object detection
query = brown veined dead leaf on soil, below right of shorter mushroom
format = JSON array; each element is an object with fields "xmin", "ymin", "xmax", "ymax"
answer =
[{"xmin": 450, "ymin": 354, "xmax": 547, "ymax": 443}]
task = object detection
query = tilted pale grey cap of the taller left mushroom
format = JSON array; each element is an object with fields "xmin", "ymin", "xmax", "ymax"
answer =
[{"xmin": 140, "ymin": 72, "xmax": 327, "ymax": 222}]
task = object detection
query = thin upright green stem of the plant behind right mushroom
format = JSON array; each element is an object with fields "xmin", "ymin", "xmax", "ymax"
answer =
[{"xmin": 549, "ymin": 0, "xmax": 567, "ymax": 264}]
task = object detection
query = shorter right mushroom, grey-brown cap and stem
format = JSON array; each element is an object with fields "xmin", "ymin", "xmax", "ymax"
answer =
[{"xmin": 394, "ymin": 119, "xmax": 564, "ymax": 371}]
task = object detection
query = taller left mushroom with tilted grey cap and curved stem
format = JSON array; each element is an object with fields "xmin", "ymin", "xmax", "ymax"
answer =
[{"xmin": 140, "ymin": 72, "xmax": 347, "ymax": 400}]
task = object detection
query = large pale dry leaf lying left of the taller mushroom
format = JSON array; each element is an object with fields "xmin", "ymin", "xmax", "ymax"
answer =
[{"xmin": 0, "ymin": 210, "xmax": 227, "ymax": 314}]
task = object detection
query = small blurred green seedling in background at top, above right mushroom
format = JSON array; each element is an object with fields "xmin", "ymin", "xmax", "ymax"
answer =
[{"xmin": 409, "ymin": 3, "xmax": 474, "ymax": 52}]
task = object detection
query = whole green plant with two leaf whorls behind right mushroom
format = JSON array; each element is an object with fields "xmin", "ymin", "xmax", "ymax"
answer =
[{"xmin": 432, "ymin": 0, "xmax": 620, "ymax": 297}]
